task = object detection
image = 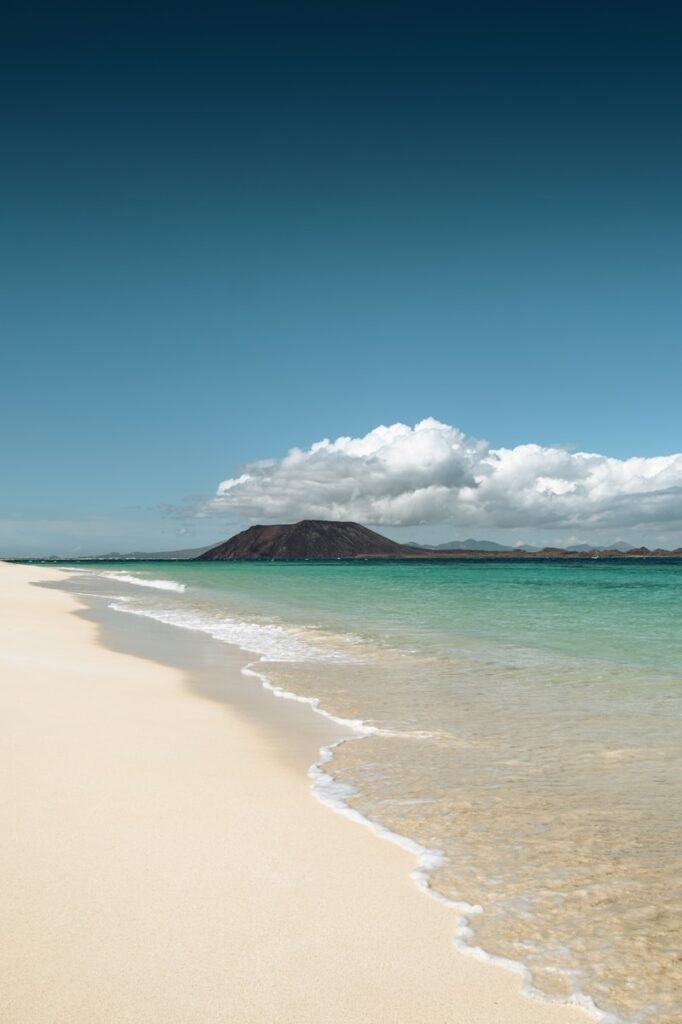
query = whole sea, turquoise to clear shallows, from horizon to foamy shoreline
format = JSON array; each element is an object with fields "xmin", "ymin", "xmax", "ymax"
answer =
[{"xmin": 58, "ymin": 559, "xmax": 682, "ymax": 1024}]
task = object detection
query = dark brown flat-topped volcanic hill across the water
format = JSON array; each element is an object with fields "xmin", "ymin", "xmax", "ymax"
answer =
[{"xmin": 199, "ymin": 519, "xmax": 409, "ymax": 561}]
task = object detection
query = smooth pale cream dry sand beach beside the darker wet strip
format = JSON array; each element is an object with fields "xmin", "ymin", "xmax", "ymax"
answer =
[{"xmin": 0, "ymin": 564, "xmax": 592, "ymax": 1024}]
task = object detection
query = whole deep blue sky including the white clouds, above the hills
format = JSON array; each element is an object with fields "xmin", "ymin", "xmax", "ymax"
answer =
[{"xmin": 0, "ymin": 0, "xmax": 682, "ymax": 556}]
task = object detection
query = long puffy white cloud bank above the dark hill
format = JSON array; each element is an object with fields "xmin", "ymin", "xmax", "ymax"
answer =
[{"xmin": 203, "ymin": 419, "xmax": 682, "ymax": 529}]
